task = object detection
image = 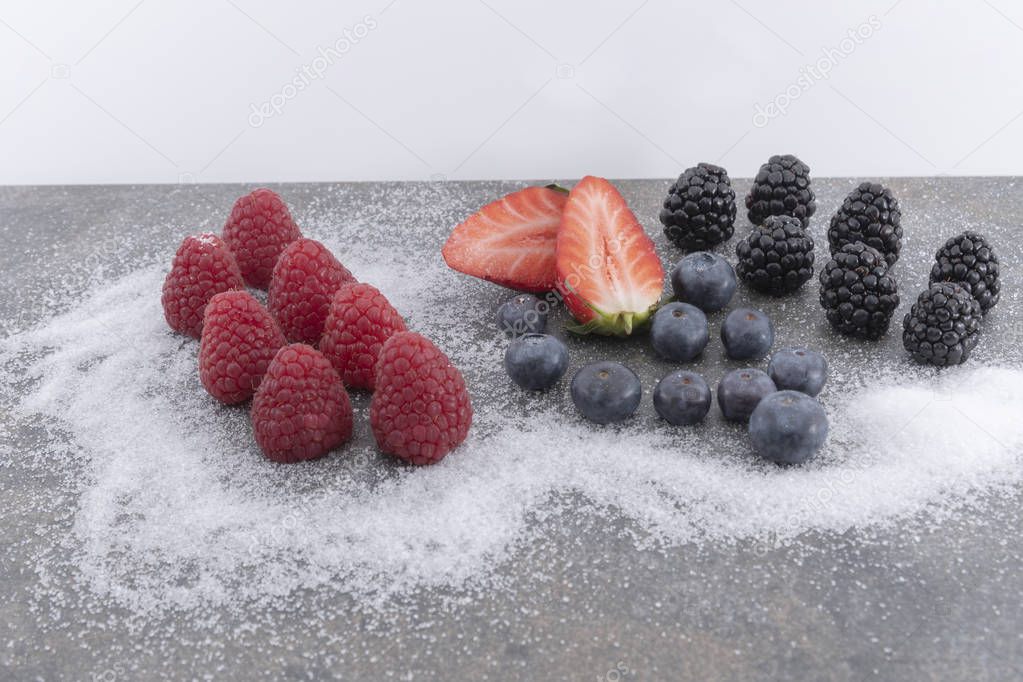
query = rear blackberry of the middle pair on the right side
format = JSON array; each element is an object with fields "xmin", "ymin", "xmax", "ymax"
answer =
[{"xmin": 828, "ymin": 182, "xmax": 902, "ymax": 267}]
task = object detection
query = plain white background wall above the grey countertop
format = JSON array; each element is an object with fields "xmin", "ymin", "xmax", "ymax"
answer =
[{"xmin": 0, "ymin": 0, "xmax": 1023, "ymax": 184}]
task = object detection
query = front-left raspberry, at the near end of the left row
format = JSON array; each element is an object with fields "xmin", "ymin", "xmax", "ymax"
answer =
[{"xmin": 252, "ymin": 344, "xmax": 352, "ymax": 463}]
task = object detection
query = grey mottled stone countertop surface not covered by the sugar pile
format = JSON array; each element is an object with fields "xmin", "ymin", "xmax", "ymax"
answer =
[{"xmin": 0, "ymin": 178, "xmax": 1023, "ymax": 681}]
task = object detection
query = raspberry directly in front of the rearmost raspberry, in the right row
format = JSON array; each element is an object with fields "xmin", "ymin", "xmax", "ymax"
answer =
[{"xmin": 267, "ymin": 238, "xmax": 355, "ymax": 345}]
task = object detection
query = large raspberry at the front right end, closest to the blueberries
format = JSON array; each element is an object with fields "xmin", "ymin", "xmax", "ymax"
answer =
[{"xmin": 369, "ymin": 331, "xmax": 473, "ymax": 464}]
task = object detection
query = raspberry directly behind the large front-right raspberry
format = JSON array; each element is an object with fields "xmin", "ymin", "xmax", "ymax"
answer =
[{"xmin": 319, "ymin": 282, "xmax": 405, "ymax": 391}]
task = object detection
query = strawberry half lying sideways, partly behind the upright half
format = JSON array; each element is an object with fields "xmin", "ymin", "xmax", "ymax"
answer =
[{"xmin": 441, "ymin": 185, "xmax": 568, "ymax": 291}]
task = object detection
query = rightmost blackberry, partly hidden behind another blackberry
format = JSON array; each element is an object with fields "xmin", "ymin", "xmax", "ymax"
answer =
[{"xmin": 931, "ymin": 231, "xmax": 1002, "ymax": 313}]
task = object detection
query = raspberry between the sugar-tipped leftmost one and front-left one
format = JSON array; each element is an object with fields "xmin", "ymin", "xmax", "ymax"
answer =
[{"xmin": 198, "ymin": 291, "xmax": 287, "ymax": 405}]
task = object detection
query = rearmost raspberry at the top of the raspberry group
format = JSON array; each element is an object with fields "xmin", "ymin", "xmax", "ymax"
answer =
[{"xmin": 223, "ymin": 189, "xmax": 302, "ymax": 289}]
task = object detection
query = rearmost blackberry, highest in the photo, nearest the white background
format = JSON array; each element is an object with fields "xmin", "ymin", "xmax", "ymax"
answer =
[{"xmin": 746, "ymin": 154, "xmax": 817, "ymax": 227}]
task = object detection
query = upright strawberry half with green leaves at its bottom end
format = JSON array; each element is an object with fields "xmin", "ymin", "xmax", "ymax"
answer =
[{"xmin": 558, "ymin": 176, "xmax": 664, "ymax": 336}]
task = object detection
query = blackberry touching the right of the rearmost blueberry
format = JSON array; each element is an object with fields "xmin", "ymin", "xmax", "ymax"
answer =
[{"xmin": 736, "ymin": 216, "xmax": 813, "ymax": 295}]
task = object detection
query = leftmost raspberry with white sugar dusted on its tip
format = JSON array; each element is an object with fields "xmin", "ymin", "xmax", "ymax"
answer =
[{"xmin": 161, "ymin": 232, "xmax": 246, "ymax": 338}]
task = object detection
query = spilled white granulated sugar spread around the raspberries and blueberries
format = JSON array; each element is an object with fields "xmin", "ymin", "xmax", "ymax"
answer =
[{"xmin": 0, "ymin": 224, "xmax": 1023, "ymax": 611}]
